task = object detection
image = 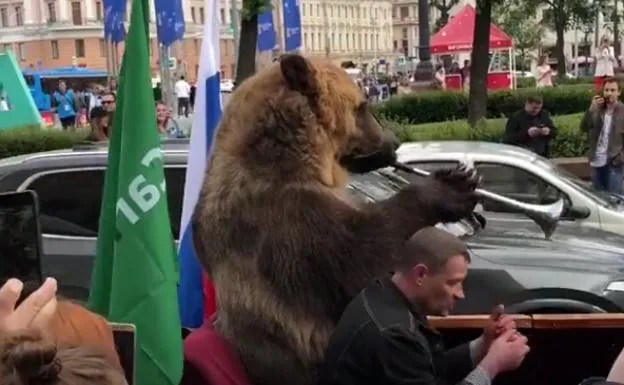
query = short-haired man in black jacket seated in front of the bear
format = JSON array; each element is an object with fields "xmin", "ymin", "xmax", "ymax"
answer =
[{"xmin": 319, "ymin": 227, "xmax": 529, "ymax": 385}]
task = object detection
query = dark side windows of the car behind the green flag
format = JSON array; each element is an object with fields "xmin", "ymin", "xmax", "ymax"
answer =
[{"xmin": 27, "ymin": 167, "xmax": 186, "ymax": 239}]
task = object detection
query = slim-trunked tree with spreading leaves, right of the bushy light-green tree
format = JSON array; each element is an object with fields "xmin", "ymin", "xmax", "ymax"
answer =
[{"xmin": 527, "ymin": 0, "xmax": 608, "ymax": 76}]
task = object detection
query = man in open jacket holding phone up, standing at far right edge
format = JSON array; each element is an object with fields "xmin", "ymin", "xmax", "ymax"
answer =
[{"xmin": 580, "ymin": 78, "xmax": 624, "ymax": 194}]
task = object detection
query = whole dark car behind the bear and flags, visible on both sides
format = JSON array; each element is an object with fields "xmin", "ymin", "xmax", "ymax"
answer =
[{"xmin": 0, "ymin": 140, "xmax": 624, "ymax": 314}]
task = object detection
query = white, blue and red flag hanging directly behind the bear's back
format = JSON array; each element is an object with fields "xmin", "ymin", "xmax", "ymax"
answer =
[{"xmin": 178, "ymin": 0, "xmax": 221, "ymax": 328}]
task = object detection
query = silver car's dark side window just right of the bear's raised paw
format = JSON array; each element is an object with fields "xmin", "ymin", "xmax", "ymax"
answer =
[{"xmin": 475, "ymin": 163, "xmax": 562, "ymax": 211}]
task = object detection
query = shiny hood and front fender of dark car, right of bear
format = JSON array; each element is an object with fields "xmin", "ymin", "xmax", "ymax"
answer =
[{"xmin": 349, "ymin": 170, "xmax": 624, "ymax": 314}]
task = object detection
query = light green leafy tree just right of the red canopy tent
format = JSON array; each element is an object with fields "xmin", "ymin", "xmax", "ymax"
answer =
[{"xmin": 492, "ymin": 0, "xmax": 544, "ymax": 68}]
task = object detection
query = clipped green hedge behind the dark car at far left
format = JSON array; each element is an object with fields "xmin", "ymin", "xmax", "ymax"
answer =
[{"xmin": 0, "ymin": 126, "xmax": 88, "ymax": 159}]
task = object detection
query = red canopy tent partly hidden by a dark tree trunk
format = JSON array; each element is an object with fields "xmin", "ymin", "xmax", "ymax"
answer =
[{"xmin": 430, "ymin": 4, "xmax": 515, "ymax": 88}]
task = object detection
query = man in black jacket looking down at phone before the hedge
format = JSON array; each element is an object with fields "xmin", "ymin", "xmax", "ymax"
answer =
[{"xmin": 503, "ymin": 95, "xmax": 557, "ymax": 158}]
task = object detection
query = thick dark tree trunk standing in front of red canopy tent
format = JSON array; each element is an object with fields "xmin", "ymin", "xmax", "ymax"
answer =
[{"xmin": 468, "ymin": 0, "xmax": 499, "ymax": 127}]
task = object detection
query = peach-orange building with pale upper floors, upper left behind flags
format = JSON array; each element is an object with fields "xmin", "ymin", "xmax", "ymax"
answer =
[{"xmin": 0, "ymin": 0, "xmax": 234, "ymax": 80}]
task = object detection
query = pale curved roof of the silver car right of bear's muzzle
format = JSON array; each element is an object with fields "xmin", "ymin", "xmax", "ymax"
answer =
[{"xmin": 397, "ymin": 140, "xmax": 537, "ymax": 162}]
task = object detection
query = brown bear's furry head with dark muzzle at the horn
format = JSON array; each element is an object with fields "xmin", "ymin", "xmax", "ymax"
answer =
[{"xmin": 213, "ymin": 54, "xmax": 399, "ymax": 187}]
